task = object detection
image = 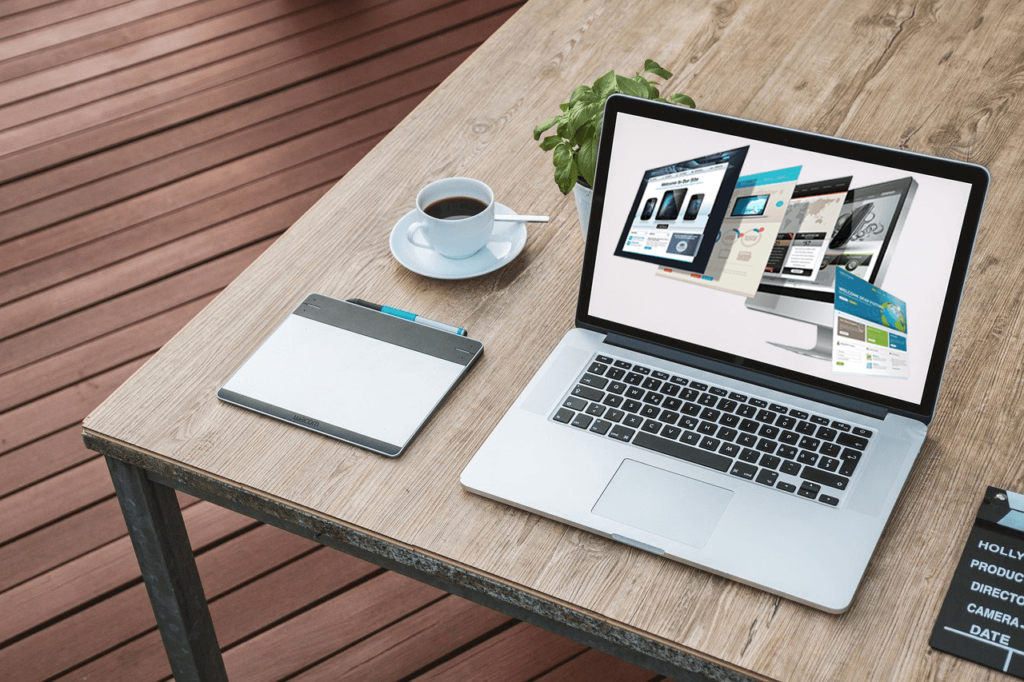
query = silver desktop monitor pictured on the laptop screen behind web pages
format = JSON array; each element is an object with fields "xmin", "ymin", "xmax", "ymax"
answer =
[{"xmin": 745, "ymin": 177, "xmax": 918, "ymax": 360}]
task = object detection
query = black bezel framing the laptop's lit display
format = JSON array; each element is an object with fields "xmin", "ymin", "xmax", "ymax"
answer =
[{"xmin": 575, "ymin": 95, "xmax": 989, "ymax": 423}]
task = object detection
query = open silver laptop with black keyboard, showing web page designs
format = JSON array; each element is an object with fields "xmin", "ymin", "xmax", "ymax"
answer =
[{"xmin": 461, "ymin": 95, "xmax": 989, "ymax": 612}]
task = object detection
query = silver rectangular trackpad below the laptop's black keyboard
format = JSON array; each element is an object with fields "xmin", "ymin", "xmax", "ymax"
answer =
[{"xmin": 593, "ymin": 460, "xmax": 732, "ymax": 548}]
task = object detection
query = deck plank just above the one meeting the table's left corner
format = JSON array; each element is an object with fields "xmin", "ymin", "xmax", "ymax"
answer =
[{"xmin": 0, "ymin": 358, "xmax": 145, "ymax": 455}]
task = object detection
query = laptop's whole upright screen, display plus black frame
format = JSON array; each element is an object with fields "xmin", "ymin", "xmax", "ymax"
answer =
[{"xmin": 578, "ymin": 97, "xmax": 987, "ymax": 415}]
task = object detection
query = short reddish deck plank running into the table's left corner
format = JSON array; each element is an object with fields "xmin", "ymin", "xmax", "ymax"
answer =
[{"xmin": 0, "ymin": 421, "xmax": 89, "ymax": 497}]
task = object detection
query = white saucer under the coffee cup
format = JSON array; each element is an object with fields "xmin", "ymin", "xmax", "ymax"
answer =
[{"xmin": 391, "ymin": 202, "xmax": 526, "ymax": 280}]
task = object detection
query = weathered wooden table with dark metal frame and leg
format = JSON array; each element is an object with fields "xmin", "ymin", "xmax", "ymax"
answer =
[{"xmin": 85, "ymin": 0, "xmax": 1024, "ymax": 679}]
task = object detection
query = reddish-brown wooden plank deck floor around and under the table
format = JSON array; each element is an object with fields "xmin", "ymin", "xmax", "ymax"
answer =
[{"xmin": 0, "ymin": 0, "xmax": 654, "ymax": 680}]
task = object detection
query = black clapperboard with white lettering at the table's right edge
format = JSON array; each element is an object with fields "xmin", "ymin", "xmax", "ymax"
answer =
[{"xmin": 929, "ymin": 487, "xmax": 1024, "ymax": 679}]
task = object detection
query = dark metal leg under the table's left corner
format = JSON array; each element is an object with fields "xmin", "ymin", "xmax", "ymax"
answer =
[{"xmin": 106, "ymin": 457, "xmax": 227, "ymax": 682}]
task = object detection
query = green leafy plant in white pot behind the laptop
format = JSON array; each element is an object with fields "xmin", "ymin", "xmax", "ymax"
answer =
[{"xmin": 534, "ymin": 59, "xmax": 696, "ymax": 239}]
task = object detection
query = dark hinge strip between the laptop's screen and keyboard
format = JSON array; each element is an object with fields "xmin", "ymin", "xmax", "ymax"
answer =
[{"xmin": 604, "ymin": 332, "xmax": 890, "ymax": 419}]
